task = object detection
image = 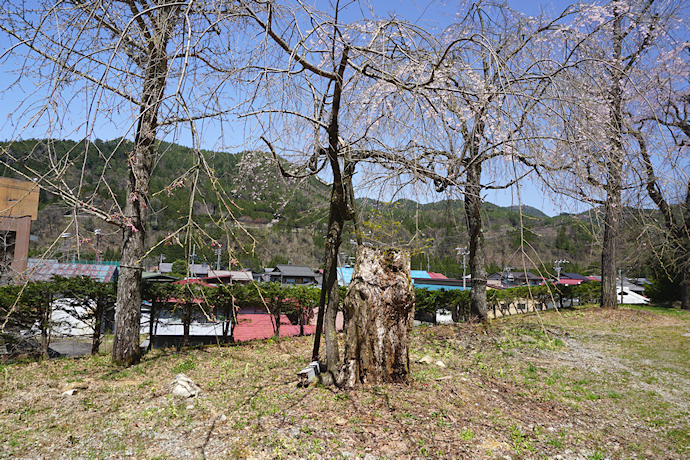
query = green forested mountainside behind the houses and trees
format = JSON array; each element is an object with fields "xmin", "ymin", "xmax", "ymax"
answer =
[{"xmin": 2, "ymin": 139, "xmax": 636, "ymax": 277}]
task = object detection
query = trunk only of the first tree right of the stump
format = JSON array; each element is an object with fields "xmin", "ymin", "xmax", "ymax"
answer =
[{"xmin": 465, "ymin": 161, "xmax": 489, "ymax": 321}]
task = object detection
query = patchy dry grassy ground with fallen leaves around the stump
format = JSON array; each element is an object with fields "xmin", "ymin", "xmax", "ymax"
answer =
[{"xmin": 0, "ymin": 308, "xmax": 690, "ymax": 459}]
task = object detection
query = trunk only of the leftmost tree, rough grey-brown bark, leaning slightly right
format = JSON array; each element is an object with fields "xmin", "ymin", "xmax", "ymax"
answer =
[{"xmin": 113, "ymin": 5, "xmax": 173, "ymax": 366}]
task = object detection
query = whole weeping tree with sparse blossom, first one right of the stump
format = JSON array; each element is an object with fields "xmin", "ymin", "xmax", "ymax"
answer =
[{"xmin": 366, "ymin": 2, "xmax": 568, "ymax": 320}]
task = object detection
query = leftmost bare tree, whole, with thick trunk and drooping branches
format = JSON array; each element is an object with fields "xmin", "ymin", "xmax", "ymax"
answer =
[{"xmin": 0, "ymin": 0, "xmax": 243, "ymax": 365}]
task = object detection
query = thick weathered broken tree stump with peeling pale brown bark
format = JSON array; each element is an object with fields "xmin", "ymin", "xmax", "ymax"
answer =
[{"xmin": 340, "ymin": 247, "xmax": 414, "ymax": 387}]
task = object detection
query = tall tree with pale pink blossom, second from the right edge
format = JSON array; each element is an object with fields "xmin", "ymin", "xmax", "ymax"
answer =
[{"xmin": 556, "ymin": 0, "xmax": 677, "ymax": 308}]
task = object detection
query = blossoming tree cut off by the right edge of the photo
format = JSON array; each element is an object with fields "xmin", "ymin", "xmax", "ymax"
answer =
[{"xmin": 629, "ymin": 19, "xmax": 690, "ymax": 310}]
